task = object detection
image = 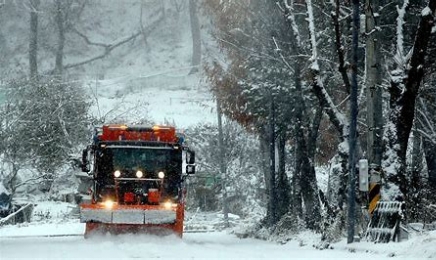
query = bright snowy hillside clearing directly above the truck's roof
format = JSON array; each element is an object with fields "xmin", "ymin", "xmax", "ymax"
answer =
[{"xmin": 87, "ymin": 70, "xmax": 216, "ymax": 129}]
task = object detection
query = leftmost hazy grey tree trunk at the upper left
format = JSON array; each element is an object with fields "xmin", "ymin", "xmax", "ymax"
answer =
[{"xmin": 29, "ymin": 0, "xmax": 39, "ymax": 80}]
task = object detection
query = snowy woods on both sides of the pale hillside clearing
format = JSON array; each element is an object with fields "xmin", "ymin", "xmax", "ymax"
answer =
[{"xmin": 0, "ymin": 0, "xmax": 436, "ymax": 244}]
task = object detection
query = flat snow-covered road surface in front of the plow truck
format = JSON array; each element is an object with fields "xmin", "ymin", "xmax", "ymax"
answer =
[{"xmin": 0, "ymin": 232, "xmax": 392, "ymax": 260}]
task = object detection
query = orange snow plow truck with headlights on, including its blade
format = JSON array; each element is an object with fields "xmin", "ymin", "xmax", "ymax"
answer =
[{"xmin": 80, "ymin": 125, "xmax": 195, "ymax": 237}]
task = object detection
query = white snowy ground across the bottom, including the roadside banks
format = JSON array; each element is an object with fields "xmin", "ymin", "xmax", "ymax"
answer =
[{"xmin": 0, "ymin": 202, "xmax": 436, "ymax": 260}]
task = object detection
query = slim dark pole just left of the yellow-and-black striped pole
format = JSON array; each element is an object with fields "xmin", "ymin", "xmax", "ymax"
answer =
[{"xmin": 347, "ymin": 0, "xmax": 360, "ymax": 243}]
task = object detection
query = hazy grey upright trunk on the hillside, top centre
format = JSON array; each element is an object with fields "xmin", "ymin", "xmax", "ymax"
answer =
[{"xmin": 189, "ymin": 0, "xmax": 201, "ymax": 74}]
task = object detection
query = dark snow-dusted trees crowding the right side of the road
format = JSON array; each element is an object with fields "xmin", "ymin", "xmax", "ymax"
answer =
[{"xmin": 205, "ymin": 0, "xmax": 436, "ymax": 240}]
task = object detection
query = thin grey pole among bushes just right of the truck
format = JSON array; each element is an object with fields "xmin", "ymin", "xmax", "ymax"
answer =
[{"xmin": 216, "ymin": 97, "xmax": 229, "ymax": 228}]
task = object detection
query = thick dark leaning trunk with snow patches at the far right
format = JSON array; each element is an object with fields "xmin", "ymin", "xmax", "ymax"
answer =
[{"xmin": 384, "ymin": 0, "xmax": 436, "ymax": 201}]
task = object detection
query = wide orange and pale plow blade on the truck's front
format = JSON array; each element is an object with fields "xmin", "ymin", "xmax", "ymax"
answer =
[{"xmin": 80, "ymin": 204, "xmax": 184, "ymax": 238}]
